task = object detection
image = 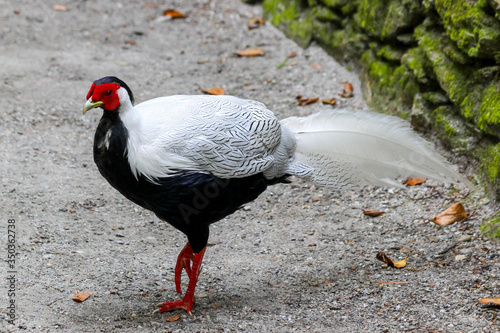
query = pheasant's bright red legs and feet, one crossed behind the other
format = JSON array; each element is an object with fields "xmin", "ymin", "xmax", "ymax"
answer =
[{"xmin": 157, "ymin": 242, "xmax": 206, "ymax": 313}]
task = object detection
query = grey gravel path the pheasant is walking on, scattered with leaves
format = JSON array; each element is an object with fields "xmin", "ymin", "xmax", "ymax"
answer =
[{"xmin": 0, "ymin": 0, "xmax": 500, "ymax": 332}]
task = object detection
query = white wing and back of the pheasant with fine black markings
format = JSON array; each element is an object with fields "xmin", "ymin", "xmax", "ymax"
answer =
[{"xmin": 128, "ymin": 95, "xmax": 281, "ymax": 178}]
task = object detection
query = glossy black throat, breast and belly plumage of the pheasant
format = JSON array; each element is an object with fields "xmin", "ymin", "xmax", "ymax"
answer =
[{"xmin": 94, "ymin": 111, "xmax": 286, "ymax": 253}]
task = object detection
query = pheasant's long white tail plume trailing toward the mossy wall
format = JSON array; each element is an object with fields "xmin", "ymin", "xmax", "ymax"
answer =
[{"xmin": 281, "ymin": 110, "xmax": 472, "ymax": 189}]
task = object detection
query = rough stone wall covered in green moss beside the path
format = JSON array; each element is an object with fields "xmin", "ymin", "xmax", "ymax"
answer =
[{"xmin": 263, "ymin": 0, "xmax": 500, "ymax": 236}]
